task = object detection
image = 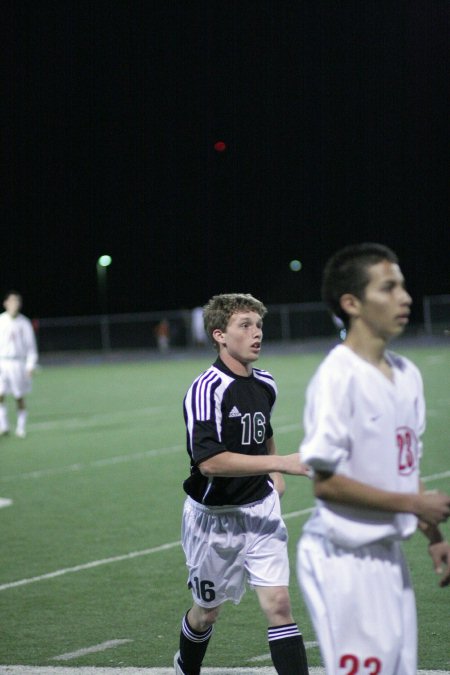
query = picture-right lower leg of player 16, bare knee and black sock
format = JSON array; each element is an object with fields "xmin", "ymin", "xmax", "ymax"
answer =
[{"xmin": 255, "ymin": 586, "xmax": 308, "ymax": 675}]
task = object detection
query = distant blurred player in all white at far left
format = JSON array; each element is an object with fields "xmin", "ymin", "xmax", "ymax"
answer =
[{"xmin": 0, "ymin": 291, "xmax": 38, "ymax": 438}]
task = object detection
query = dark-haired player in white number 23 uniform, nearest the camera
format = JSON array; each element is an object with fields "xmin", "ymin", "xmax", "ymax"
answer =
[{"xmin": 297, "ymin": 244, "xmax": 450, "ymax": 675}]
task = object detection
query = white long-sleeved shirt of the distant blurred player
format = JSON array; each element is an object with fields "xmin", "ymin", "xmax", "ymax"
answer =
[{"xmin": 0, "ymin": 312, "xmax": 38, "ymax": 370}]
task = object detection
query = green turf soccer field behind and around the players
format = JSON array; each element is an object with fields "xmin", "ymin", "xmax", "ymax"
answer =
[{"xmin": 0, "ymin": 348, "xmax": 450, "ymax": 670}]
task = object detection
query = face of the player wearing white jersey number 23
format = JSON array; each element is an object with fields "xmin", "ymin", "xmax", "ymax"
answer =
[{"xmin": 358, "ymin": 260, "xmax": 412, "ymax": 339}]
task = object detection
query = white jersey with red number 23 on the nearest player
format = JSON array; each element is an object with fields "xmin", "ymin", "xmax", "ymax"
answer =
[{"xmin": 300, "ymin": 345, "xmax": 425, "ymax": 548}]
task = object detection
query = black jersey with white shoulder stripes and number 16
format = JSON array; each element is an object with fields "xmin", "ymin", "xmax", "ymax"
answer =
[{"xmin": 183, "ymin": 358, "xmax": 277, "ymax": 506}]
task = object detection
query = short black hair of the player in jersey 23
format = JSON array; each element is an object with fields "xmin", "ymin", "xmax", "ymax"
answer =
[{"xmin": 322, "ymin": 243, "xmax": 398, "ymax": 328}]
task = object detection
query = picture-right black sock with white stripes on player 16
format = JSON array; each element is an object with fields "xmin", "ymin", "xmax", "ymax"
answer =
[{"xmin": 267, "ymin": 623, "xmax": 308, "ymax": 675}]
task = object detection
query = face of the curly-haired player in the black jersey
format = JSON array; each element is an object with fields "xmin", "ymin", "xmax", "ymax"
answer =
[{"xmin": 216, "ymin": 311, "xmax": 263, "ymax": 364}]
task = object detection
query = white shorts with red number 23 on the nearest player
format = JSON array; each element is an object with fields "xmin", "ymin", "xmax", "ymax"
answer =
[{"xmin": 297, "ymin": 534, "xmax": 417, "ymax": 675}]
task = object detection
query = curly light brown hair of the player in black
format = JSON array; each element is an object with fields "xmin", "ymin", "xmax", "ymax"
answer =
[{"xmin": 203, "ymin": 293, "xmax": 267, "ymax": 349}]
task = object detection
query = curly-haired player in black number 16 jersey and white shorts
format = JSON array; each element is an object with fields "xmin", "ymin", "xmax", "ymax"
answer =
[{"xmin": 174, "ymin": 293, "xmax": 308, "ymax": 675}]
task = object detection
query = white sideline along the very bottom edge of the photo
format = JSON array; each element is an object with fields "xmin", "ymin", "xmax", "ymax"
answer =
[{"xmin": 0, "ymin": 665, "xmax": 450, "ymax": 675}]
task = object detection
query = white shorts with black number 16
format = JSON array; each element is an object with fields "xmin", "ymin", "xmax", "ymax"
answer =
[{"xmin": 181, "ymin": 490, "xmax": 289, "ymax": 608}]
